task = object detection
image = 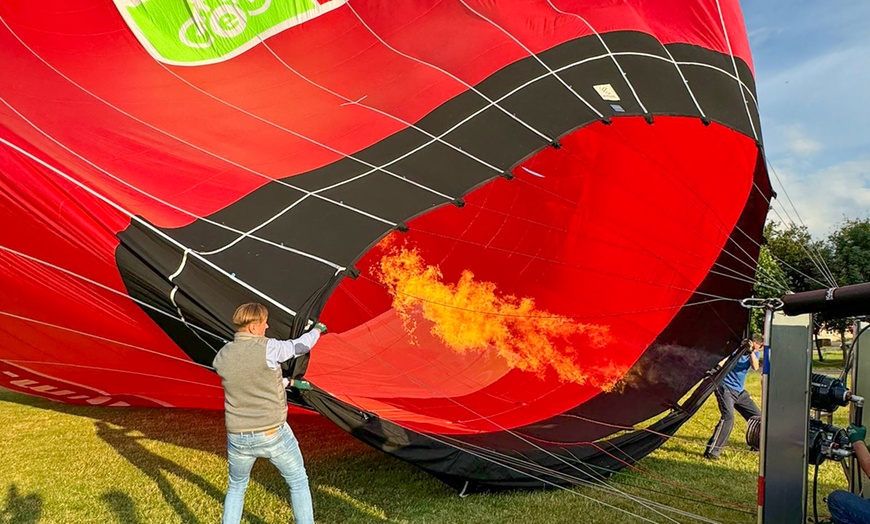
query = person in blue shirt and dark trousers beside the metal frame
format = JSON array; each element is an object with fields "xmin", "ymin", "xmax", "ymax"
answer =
[{"xmin": 704, "ymin": 334, "xmax": 764, "ymax": 460}]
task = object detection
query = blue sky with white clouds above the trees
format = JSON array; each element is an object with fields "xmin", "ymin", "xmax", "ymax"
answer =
[{"xmin": 741, "ymin": 0, "xmax": 870, "ymax": 239}]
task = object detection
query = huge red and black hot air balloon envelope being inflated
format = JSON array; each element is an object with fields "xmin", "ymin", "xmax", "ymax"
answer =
[{"xmin": 0, "ymin": 0, "xmax": 770, "ymax": 487}]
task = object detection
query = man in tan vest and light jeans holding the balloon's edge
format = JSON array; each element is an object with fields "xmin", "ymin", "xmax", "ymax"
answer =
[{"xmin": 214, "ymin": 302, "xmax": 326, "ymax": 524}]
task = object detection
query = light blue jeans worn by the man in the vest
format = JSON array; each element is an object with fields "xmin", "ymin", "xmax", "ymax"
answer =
[{"xmin": 221, "ymin": 422, "xmax": 314, "ymax": 524}]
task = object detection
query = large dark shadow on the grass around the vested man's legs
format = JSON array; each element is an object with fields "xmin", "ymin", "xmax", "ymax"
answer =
[{"xmin": 0, "ymin": 388, "xmax": 450, "ymax": 524}]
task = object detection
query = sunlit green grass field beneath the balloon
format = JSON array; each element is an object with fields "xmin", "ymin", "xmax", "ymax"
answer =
[{"xmin": 0, "ymin": 351, "xmax": 846, "ymax": 524}]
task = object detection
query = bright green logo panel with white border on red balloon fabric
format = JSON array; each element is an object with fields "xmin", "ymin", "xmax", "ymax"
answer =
[{"xmin": 114, "ymin": 0, "xmax": 347, "ymax": 65}]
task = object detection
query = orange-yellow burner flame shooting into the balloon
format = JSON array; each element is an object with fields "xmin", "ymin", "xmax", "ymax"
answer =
[{"xmin": 375, "ymin": 237, "xmax": 625, "ymax": 391}]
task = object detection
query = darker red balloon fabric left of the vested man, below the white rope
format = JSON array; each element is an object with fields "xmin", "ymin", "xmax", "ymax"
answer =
[{"xmin": 0, "ymin": 143, "xmax": 223, "ymax": 408}]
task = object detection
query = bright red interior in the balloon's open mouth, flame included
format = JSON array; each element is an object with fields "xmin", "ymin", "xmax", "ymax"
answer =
[{"xmin": 307, "ymin": 117, "xmax": 756, "ymax": 434}]
